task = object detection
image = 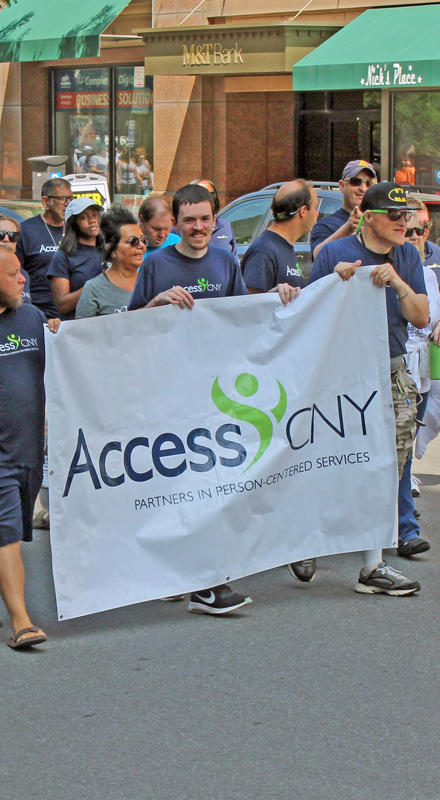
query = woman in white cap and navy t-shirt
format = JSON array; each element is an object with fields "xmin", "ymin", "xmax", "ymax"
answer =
[{"xmin": 47, "ymin": 197, "xmax": 104, "ymax": 320}]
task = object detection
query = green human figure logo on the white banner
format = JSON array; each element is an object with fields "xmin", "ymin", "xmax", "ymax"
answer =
[{"xmin": 211, "ymin": 372, "xmax": 287, "ymax": 472}]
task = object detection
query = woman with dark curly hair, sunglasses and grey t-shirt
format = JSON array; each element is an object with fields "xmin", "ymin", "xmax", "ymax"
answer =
[{"xmin": 76, "ymin": 205, "xmax": 147, "ymax": 319}]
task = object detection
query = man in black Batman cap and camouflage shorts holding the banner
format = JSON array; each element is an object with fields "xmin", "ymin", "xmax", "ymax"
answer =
[{"xmin": 310, "ymin": 182, "xmax": 429, "ymax": 595}]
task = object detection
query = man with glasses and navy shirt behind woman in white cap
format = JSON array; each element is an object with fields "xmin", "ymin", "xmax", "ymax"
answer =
[{"xmin": 16, "ymin": 178, "xmax": 73, "ymax": 319}]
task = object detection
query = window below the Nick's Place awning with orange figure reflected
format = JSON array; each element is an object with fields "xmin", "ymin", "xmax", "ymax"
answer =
[{"xmin": 393, "ymin": 91, "xmax": 440, "ymax": 186}]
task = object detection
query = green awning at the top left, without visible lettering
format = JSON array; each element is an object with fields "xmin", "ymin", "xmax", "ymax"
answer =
[{"xmin": 0, "ymin": 0, "xmax": 129, "ymax": 62}]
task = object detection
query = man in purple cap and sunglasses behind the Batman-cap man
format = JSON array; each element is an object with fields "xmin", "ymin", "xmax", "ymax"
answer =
[{"xmin": 310, "ymin": 159, "xmax": 377, "ymax": 258}]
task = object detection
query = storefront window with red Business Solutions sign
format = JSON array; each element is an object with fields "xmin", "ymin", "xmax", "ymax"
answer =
[{"xmin": 54, "ymin": 67, "xmax": 154, "ymax": 210}]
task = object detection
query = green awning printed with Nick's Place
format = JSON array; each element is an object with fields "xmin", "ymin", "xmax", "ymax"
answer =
[{"xmin": 293, "ymin": 3, "xmax": 440, "ymax": 92}]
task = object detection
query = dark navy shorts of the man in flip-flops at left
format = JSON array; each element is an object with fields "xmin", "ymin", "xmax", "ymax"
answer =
[{"xmin": 0, "ymin": 466, "xmax": 43, "ymax": 547}]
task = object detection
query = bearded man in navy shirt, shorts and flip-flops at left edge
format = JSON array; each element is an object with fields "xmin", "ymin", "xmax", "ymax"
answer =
[{"xmin": 0, "ymin": 247, "xmax": 52, "ymax": 649}]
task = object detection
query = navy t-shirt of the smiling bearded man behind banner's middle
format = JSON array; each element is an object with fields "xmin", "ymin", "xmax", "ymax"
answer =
[{"xmin": 128, "ymin": 245, "xmax": 248, "ymax": 311}]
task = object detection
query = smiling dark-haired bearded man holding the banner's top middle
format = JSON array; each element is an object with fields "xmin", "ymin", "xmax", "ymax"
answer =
[{"xmin": 129, "ymin": 184, "xmax": 300, "ymax": 615}]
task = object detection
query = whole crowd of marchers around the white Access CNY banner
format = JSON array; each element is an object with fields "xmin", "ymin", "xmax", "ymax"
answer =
[{"xmin": 0, "ymin": 160, "xmax": 440, "ymax": 649}]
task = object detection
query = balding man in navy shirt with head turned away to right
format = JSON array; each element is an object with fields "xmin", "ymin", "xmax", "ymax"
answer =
[{"xmin": 241, "ymin": 178, "xmax": 318, "ymax": 583}]
